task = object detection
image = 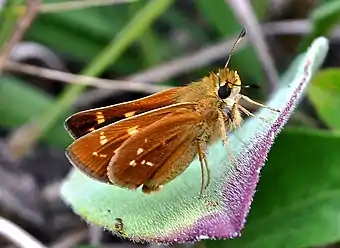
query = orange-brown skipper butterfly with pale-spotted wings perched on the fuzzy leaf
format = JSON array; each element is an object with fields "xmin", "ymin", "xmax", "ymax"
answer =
[{"xmin": 65, "ymin": 68, "xmax": 255, "ymax": 193}]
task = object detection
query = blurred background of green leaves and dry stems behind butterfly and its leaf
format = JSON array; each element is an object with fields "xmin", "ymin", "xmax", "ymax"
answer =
[{"xmin": 0, "ymin": 0, "xmax": 340, "ymax": 248}]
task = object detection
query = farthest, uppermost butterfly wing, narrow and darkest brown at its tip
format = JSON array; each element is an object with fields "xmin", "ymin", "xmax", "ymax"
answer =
[{"xmin": 65, "ymin": 87, "xmax": 183, "ymax": 139}]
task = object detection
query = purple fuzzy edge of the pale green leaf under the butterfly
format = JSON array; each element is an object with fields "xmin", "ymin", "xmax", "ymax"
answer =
[{"xmin": 139, "ymin": 38, "xmax": 327, "ymax": 244}]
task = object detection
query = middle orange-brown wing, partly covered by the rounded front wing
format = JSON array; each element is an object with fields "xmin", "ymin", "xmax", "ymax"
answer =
[{"xmin": 66, "ymin": 103, "xmax": 196, "ymax": 182}]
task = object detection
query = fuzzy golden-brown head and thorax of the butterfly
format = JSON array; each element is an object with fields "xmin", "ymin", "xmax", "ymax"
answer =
[{"xmin": 174, "ymin": 68, "xmax": 241, "ymax": 145}]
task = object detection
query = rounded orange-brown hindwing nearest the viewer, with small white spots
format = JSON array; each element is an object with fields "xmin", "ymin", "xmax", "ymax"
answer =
[{"xmin": 108, "ymin": 109, "xmax": 201, "ymax": 189}]
